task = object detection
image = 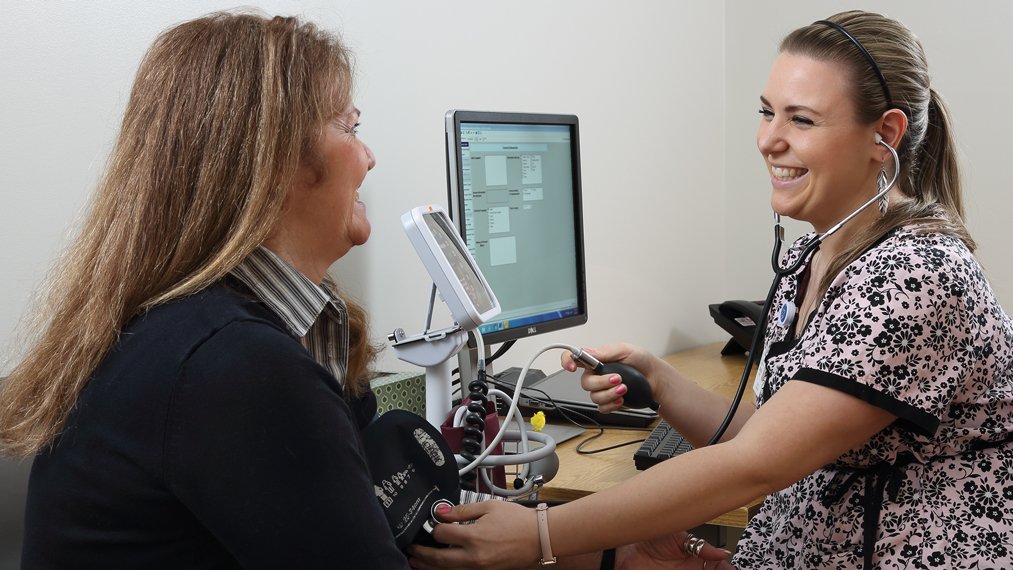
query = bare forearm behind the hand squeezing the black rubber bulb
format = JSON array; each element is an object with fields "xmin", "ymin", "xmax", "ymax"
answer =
[{"xmin": 653, "ymin": 358, "xmax": 754, "ymax": 447}]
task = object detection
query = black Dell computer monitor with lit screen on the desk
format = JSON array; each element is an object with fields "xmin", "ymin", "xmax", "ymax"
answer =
[{"xmin": 446, "ymin": 110, "xmax": 588, "ymax": 345}]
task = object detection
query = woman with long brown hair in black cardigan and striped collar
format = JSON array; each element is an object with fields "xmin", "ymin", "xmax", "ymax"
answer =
[{"xmin": 0, "ymin": 14, "xmax": 405, "ymax": 568}]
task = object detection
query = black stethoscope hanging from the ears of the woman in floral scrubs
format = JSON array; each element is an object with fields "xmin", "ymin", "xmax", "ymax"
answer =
[{"xmin": 707, "ymin": 133, "xmax": 901, "ymax": 445}]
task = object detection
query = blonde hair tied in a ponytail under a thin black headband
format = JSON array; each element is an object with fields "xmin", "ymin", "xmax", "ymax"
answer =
[{"xmin": 780, "ymin": 10, "xmax": 975, "ymax": 295}]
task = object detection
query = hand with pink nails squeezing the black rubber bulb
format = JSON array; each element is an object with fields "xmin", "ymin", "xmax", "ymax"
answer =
[{"xmin": 560, "ymin": 343, "xmax": 657, "ymax": 413}]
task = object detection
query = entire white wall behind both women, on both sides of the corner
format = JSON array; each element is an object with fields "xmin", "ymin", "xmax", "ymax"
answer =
[{"xmin": 0, "ymin": 0, "xmax": 1013, "ymax": 375}]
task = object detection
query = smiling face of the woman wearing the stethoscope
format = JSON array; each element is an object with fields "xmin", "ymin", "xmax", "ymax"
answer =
[{"xmin": 757, "ymin": 53, "xmax": 880, "ymax": 232}]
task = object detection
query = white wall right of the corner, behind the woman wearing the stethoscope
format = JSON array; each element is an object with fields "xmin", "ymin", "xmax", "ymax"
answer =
[{"xmin": 723, "ymin": 0, "xmax": 1013, "ymax": 312}]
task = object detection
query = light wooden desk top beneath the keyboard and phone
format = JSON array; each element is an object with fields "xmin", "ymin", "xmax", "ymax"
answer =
[{"xmin": 539, "ymin": 342, "xmax": 763, "ymax": 528}]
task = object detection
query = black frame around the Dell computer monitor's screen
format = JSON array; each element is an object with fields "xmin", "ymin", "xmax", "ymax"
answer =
[{"xmin": 445, "ymin": 109, "xmax": 588, "ymax": 344}]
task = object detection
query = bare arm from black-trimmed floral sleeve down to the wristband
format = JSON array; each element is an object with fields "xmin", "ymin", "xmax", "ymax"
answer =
[{"xmin": 550, "ymin": 382, "xmax": 897, "ymax": 554}]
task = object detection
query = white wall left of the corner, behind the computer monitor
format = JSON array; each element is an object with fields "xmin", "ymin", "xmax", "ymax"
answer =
[{"xmin": 0, "ymin": 0, "xmax": 724, "ymax": 374}]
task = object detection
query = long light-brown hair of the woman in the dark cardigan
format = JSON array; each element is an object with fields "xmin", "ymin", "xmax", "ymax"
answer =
[{"xmin": 0, "ymin": 13, "xmax": 375, "ymax": 456}]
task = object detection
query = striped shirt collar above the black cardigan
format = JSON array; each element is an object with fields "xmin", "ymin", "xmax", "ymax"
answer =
[{"xmin": 231, "ymin": 246, "xmax": 341, "ymax": 338}]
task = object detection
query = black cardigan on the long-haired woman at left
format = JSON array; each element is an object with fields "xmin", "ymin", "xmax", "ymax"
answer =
[{"xmin": 22, "ymin": 282, "xmax": 407, "ymax": 569}]
